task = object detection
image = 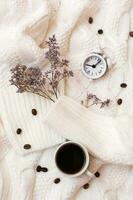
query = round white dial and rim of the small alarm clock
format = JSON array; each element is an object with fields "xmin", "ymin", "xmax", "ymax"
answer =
[{"xmin": 83, "ymin": 53, "xmax": 107, "ymax": 79}]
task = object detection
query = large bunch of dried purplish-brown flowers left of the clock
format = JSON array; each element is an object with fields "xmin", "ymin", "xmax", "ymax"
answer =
[{"xmin": 10, "ymin": 35, "xmax": 74, "ymax": 102}]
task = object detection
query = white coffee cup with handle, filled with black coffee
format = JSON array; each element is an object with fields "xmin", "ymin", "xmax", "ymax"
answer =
[{"xmin": 54, "ymin": 141, "xmax": 94, "ymax": 177}]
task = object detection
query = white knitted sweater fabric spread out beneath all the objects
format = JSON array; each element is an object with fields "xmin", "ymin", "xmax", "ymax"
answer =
[{"xmin": 0, "ymin": 0, "xmax": 133, "ymax": 200}]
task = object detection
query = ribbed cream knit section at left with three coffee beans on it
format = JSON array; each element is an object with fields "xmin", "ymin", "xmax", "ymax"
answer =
[{"xmin": 0, "ymin": 86, "xmax": 65, "ymax": 154}]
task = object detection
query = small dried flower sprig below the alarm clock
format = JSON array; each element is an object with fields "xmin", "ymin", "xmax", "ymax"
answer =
[{"xmin": 81, "ymin": 93, "xmax": 111, "ymax": 108}]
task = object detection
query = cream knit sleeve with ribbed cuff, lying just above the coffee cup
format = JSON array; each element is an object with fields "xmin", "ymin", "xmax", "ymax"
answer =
[{"xmin": 45, "ymin": 97, "xmax": 133, "ymax": 165}]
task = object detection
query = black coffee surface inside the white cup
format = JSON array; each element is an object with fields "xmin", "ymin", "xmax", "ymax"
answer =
[{"xmin": 55, "ymin": 143, "xmax": 86, "ymax": 174}]
